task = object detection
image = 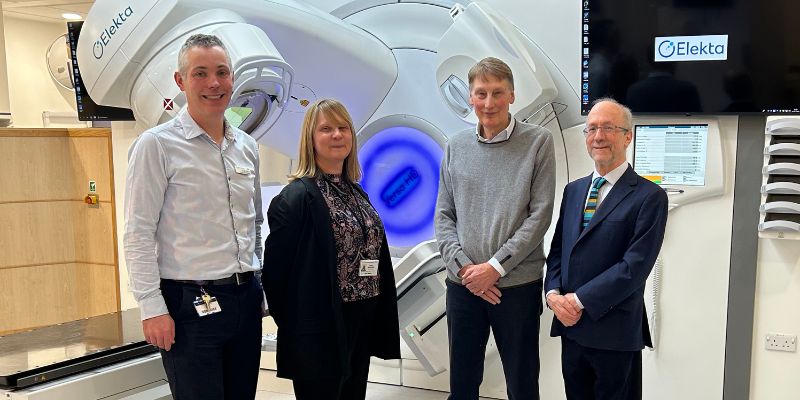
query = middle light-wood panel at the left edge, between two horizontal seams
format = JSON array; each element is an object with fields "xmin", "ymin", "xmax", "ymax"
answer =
[{"xmin": 0, "ymin": 201, "xmax": 75, "ymax": 268}]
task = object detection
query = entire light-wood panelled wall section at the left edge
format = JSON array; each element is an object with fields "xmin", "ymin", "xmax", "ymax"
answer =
[{"xmin": 0, "ymin": 129, "xmax": 119, "ymax": 334}]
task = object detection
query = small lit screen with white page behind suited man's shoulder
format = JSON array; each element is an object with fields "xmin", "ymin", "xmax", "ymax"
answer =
[{"xmin": 633, "ymin": 125, "xmax": 708, "ymax": 186}]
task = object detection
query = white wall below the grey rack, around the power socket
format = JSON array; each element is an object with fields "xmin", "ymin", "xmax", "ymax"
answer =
[{"xmin": 750, "ymin": 118, "xmax": 800, "ymax": 400}]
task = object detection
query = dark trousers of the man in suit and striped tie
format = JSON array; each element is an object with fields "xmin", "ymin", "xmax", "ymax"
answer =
[{"xmin": 561, "ymin": 338, "xmax": 642, "ymax": 400}]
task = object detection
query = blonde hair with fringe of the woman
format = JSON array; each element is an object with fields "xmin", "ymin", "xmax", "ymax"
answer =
[{"xmin": 289, "ymin": 99, "xmax": 361, "ymax": 182}]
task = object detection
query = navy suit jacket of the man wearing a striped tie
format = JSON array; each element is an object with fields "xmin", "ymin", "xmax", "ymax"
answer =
[{"xmin": 544, "ymin": 166, "xmax": 667, "ymax": 351}]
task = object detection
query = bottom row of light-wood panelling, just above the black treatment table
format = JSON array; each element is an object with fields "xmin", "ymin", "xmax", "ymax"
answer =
[{"xmin": 0, "ymin": 263, "xmax": 117, "ymax": 332}]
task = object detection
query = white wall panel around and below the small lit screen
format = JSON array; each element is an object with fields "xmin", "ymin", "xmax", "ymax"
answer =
[{"xmin": 636, "ymin": 117, "xmax": 737, "ymax": 400}]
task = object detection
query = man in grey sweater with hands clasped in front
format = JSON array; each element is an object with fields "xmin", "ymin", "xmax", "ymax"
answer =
[{"xmin": 435, "ymin": 57, "xmax": 555, "ymax": 400}]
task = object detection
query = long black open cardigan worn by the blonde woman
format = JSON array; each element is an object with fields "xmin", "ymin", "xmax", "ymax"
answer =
[{"xmin": 261, "ymin": 178, "xmax": 400, "ymax": 380}]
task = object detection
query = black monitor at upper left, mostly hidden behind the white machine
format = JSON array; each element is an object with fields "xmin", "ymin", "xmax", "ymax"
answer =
[{"xmin": 67, "ymin": 21, "xmax": 134, "ymax": 121}]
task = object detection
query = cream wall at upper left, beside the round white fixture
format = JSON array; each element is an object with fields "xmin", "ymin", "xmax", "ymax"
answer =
[{"xmin": 3, "ymin": 17, "xmax": 79, "ymax": 128}]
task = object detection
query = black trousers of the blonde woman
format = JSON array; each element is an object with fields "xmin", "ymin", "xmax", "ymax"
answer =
[{"xmin": 292, "ymin": 297, "xmax": 382, "ymax": 400}]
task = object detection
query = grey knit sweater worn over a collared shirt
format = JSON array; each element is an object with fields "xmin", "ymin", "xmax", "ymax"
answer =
[{"xmin": 435, "ymin": 121, "xmax": 556, "ymax": 287}]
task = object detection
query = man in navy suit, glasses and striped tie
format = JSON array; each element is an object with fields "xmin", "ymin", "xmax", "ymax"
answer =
[{"xmin": 544, "ymin": 99, "xmax": 667, "ymax": 400}]
